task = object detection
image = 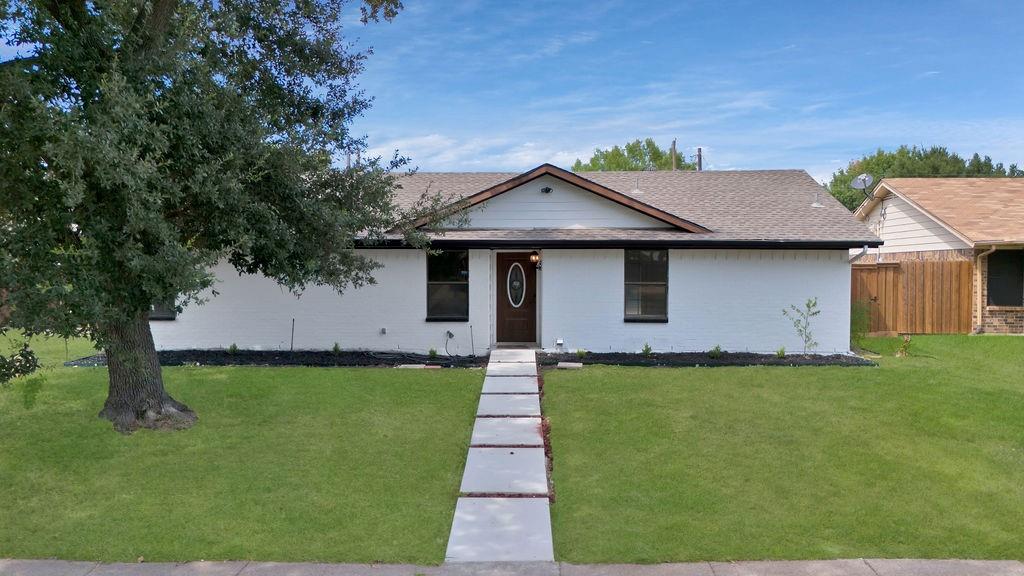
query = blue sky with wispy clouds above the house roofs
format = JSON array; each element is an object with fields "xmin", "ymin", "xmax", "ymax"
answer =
[{"xmin": 349, "ymin": 0, "xmax": 1024, "ymax": 179}]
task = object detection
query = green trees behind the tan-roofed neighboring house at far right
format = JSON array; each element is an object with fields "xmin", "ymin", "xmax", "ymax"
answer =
[{"xmin": 827, "ymin": 146, "xmax": 1024, "ymax": 210}]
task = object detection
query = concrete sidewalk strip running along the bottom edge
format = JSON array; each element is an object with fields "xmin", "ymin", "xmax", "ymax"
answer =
[{"xmin": 0, "ymin": 559, "xmax": 1024, "ymax": 576}]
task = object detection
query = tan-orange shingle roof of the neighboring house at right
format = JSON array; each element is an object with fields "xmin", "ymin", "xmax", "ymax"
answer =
[{"xmin": 855, "ymin": 177, "xmax": 1024, "ymax": 245}]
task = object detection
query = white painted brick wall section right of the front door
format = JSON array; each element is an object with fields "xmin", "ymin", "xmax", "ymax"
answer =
[{"xmin": 542, "ymin": 249, "xmax": 850, "ymax": 353}]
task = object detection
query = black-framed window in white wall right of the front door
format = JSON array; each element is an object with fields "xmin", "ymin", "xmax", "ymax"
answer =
[{"xmin": 625, "ymin": 250, "xmax": 669, "ymax": 322}]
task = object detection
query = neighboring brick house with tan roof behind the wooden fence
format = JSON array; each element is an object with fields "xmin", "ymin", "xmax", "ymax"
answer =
[{"xmin": 854, "ymin": 178, "xmax": 1024, "ymax": 334}]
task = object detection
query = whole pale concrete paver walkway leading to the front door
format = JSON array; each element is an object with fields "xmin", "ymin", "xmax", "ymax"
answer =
[{"xmin": 444, "ymin": 349, "xmax": 554, "ymax": 563}]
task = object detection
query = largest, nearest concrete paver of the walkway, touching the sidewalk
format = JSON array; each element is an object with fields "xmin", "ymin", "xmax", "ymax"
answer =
[{"xmin": 444, "ymin": 498, "xmax": 555, "ymax": 562}]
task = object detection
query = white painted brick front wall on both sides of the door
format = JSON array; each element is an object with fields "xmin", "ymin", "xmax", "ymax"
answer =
[{"xmin": 152, "ymin": 249, "xmax": 850, "ymax": 355}]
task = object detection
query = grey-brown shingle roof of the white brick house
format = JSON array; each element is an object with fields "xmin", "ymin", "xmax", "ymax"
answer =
[{"xmin": 397, "ymin": 165, "xmax": 880, "ymax": 247}]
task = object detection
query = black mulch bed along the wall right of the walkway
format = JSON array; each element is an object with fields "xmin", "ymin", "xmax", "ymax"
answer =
[{"xmin": 537, "ymin": 352, "xmax": 878, "ymax": 367}]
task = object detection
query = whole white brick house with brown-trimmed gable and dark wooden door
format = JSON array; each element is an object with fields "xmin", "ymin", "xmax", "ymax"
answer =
[{"xmin": 153, "ymin": 164, "xmax": 881, "ymax": 355}]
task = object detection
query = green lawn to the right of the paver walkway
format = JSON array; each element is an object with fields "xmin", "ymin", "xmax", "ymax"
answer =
[{"xmin": 544, "ymin": 336, "xmax": 1024, "ymax": 563}]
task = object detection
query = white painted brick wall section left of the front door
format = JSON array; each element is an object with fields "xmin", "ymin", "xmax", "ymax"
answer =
[{"xmin": 151, "ymin": 249, "xmax": 490, "ymax": 355}]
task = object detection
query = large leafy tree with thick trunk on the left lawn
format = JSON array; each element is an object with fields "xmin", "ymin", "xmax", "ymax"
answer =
[{"xmin": 0, "ymin": 0, "xmax": 436, "ymax": 431}]
